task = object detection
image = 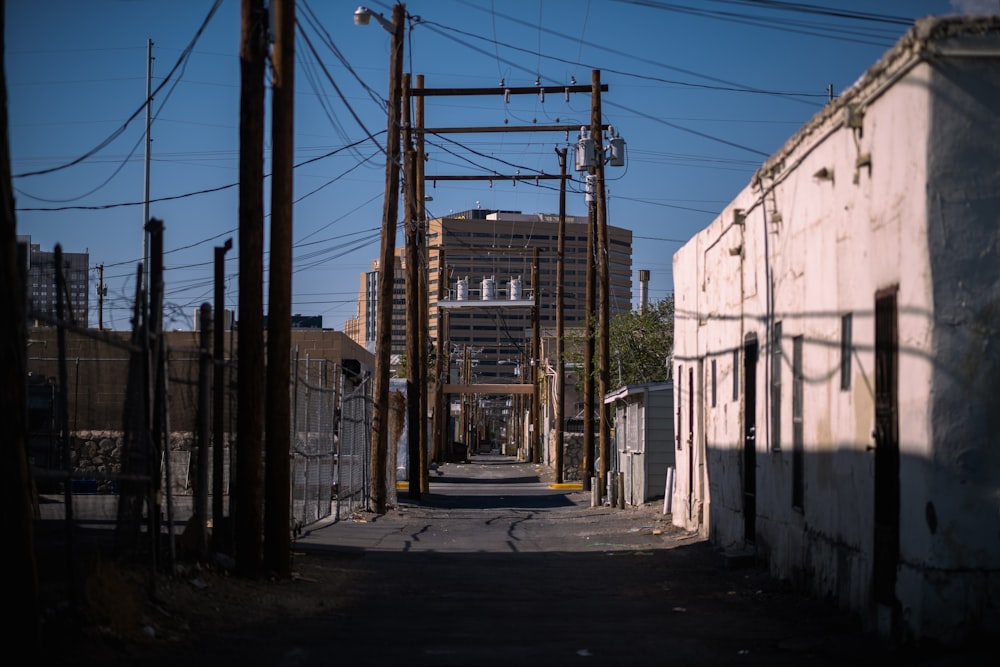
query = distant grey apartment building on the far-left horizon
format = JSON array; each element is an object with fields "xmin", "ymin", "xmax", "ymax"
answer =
[{"xmin": 17, "ymin": 236, "xmax": 90, "ymax": 327}]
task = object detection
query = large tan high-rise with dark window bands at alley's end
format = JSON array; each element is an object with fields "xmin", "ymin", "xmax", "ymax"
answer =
[{"xmin": 424, "ymin": 209, "xmax": 632, "ymax": 383}]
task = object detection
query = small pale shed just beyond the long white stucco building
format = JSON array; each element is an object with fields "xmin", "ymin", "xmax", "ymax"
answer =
[{"xmin": 604, "ymin": 380, "xmax": 674, "ymax": 505}]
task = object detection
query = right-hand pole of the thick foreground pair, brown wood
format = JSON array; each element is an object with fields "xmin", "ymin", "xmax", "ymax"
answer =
[{"xmin": 264, "ymin": 0, "xmax": 295, "ymax": 577}]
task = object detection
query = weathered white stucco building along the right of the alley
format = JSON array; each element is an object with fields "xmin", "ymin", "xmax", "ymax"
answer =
[{"xmin": 672, "ymin": 17, "xmax": 1000, "ymax": 643}]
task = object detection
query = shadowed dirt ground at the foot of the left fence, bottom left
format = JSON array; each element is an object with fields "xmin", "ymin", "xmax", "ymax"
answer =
[{"xmin": 39, "ymin": 524, "xmax": 368, "ymax": 667}]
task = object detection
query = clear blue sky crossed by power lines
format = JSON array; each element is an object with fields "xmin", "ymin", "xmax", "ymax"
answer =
[{"xmin": 5, "ymin": 0, "xmax": 1000, "ymax": 329}]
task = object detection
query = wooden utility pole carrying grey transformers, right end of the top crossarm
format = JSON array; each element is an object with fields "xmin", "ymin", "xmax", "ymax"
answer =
[{"xmin": 590, "ymin": 70, "xmax": 611, "ymax": 504}]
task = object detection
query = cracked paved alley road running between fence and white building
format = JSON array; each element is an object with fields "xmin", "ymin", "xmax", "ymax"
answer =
[{"xmin": 43, "ymin": 456, "xmax": 993, "ymax": 667}]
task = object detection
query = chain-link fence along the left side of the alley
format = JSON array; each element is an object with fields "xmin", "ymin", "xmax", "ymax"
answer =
[{"xmin": 28, "ymin": 327, "xmax": 373, "ymax": 529}]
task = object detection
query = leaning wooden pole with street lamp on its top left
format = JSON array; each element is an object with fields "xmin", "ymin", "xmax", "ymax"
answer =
[{"xmin": 354, "ymin": 3, "xmax": 406, "ymax": 514}]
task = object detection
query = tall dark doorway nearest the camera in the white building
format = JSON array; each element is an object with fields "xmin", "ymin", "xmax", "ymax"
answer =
[{"xmin": 872, "ymin": 288, "xmax": 900, "ymax": 606}]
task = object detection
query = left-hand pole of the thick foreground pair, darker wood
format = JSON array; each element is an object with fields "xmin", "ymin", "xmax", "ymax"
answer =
[{"xmin": 231, "ymin": 0, "xmax": 267, "ymax": 576}]
